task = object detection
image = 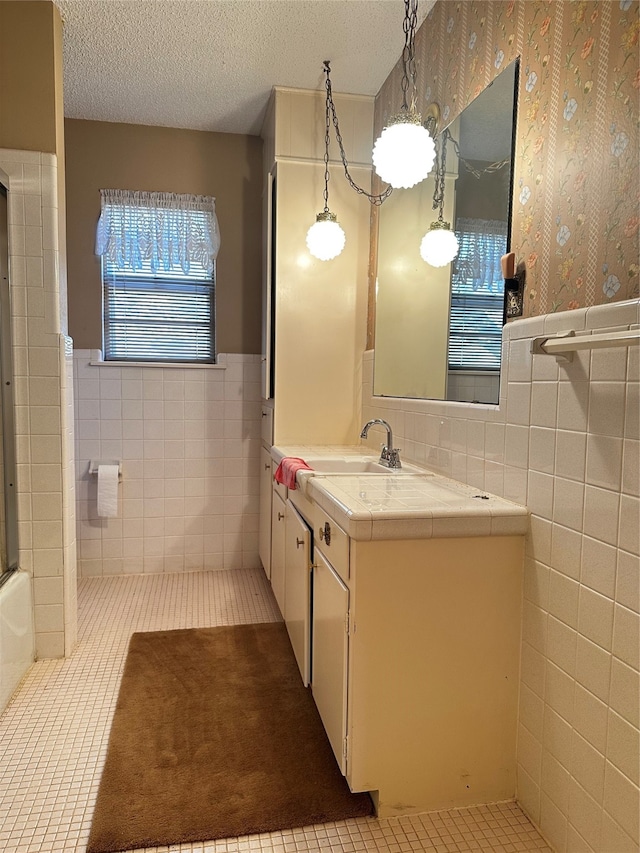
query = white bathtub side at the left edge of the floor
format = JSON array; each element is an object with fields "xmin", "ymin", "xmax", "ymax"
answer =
[{"xmin": 0, "ymin": 571, "xmax": 35, "ymax": 712}]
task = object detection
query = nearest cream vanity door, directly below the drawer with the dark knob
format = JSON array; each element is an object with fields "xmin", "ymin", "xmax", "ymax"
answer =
[{"xmin": 311, "ymin": 550, "xmax": 349, "ymax": 774}]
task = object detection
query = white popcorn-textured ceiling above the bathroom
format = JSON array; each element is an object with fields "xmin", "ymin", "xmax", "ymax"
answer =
[{"xmin": 55, "ymin": 0, "xmax": 435, "ymax": 134}]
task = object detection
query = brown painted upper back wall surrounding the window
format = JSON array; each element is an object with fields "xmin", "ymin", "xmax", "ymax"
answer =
[{"xmin": 65, "ymin": 119, "xmax": 262, "ymax": 353}]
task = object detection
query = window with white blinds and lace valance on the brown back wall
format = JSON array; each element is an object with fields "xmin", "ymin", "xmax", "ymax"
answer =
[{"xmin": 97, "ymin": 190, "xmax": 220, "ymax": 363}]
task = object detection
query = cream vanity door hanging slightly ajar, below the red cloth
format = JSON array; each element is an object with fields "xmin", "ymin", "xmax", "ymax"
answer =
[{"xmin": 284, "ymin": 500, "xmax": 311, "ymax": 687}]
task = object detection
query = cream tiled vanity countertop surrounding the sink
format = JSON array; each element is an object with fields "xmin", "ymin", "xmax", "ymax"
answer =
[{"xmin": 273, "ymin": 446, "xmax": 529, "ymax": 540}]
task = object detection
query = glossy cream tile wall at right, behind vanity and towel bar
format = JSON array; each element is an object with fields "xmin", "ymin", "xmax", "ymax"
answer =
[{"xmin": 363, "ymin": 300, "xmax": 640, "ymax": 853}]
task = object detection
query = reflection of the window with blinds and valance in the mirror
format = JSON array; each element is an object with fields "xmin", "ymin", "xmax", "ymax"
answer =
[{"xmin": 449, "ymin": 218, "xmax": 507, "ymax": 370}]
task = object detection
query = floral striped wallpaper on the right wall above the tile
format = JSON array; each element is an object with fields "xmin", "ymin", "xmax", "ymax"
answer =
[{"xmin": 372, "ymin": 0, "xmax": 640, "ymax": 316}]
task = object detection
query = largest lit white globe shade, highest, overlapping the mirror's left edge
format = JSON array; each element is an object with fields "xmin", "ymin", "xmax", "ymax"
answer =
[{"xmin": 373, "ymin": 113, "xmax": 436, "ymax": 189}]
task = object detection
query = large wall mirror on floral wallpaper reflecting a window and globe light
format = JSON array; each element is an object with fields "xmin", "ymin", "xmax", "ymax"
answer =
[{"xmin": 373, "ymin": 60, "xmax": 518, "ymax": 404}]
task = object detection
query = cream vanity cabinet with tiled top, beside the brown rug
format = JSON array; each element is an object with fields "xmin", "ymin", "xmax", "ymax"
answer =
[{"xmin": 274, "ymin": 453, "xmax": 527, "ymax": 816}]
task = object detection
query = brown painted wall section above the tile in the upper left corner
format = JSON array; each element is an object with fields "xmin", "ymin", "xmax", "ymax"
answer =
[{"xmin": 0, "ymin": 0, "xmax": 63, "ymax": 154}]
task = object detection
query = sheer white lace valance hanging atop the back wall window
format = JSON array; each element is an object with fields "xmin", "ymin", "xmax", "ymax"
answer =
[{"xmin": 96, "ymin": 190, "xmax": 220, "ymax": 275}]
